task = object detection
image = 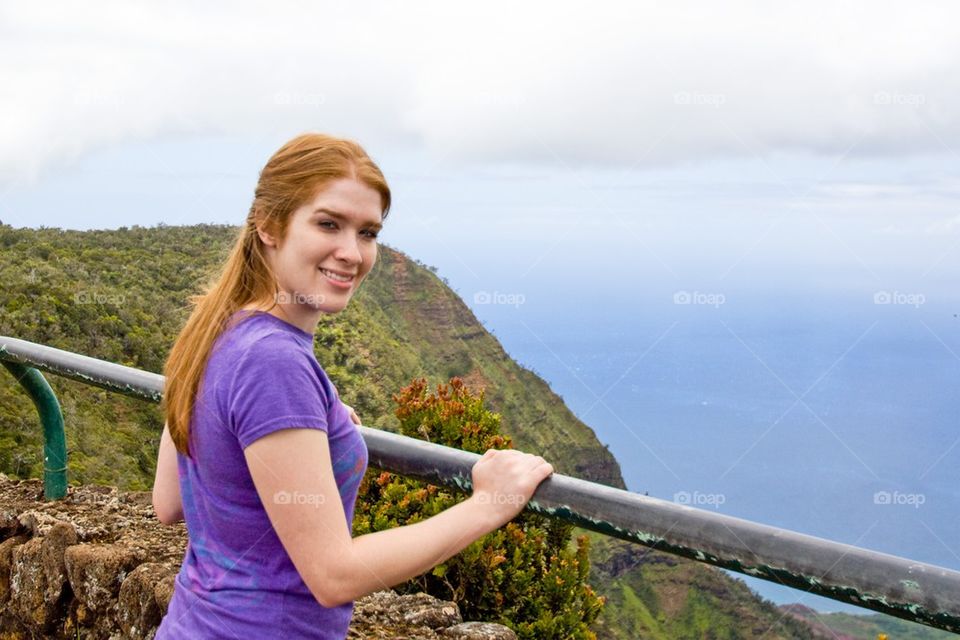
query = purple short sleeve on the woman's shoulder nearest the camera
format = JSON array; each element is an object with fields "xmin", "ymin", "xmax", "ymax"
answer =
[{"xmin": 227, "ymin": 333, "xmax": 329, "ymax": 449}]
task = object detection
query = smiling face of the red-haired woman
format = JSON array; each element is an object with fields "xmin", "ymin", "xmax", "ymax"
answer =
[{"xmin": 260, "ymin": 178, "xmax": 383, "ymax": 333}]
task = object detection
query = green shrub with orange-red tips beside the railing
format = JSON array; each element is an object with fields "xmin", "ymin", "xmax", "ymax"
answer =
[{"xmin": 353, "ymin": 378, "xmax": 604, "ymax": 640}]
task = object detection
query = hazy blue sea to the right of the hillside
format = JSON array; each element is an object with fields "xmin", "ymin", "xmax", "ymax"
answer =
[{"xmin": 464, "ymin": 287, "xmax": 960, "ymax": 613}]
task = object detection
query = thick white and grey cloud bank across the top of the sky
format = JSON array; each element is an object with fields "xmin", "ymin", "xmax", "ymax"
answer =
[{"xmin": 0, "ymin": 2, "xmax": 960, "ymax": 180}]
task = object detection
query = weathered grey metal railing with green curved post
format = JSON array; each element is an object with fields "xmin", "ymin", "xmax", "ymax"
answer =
[{"xmin": 0, "ymin": 337, "xmax": 960, "ymax": 633}]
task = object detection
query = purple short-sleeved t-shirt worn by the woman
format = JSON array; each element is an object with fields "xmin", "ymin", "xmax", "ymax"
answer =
[{"xmin": 156, "ymin": 312, "xmax": 367, "ymax": 640}]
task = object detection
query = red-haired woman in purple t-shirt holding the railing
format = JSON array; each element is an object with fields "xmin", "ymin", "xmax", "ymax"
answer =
[{"xmin": 153, "ymin": 134, "xmax": 553, "ymax": 640}]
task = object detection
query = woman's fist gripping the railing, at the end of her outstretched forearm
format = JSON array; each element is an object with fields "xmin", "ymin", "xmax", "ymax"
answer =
[{"xmin": 471, "ymin": 449, "xmax": 553, "ymax": 526}]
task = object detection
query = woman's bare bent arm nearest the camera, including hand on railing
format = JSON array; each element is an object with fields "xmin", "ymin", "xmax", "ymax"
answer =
[{"xmin": 245, "ymin": 429, "xmax": 553, "ymax": 607}]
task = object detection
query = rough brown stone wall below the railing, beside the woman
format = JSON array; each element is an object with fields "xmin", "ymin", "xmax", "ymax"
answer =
[{"xmin": 0, "ymin": 474, "xmax": 516, "ymax": 640}]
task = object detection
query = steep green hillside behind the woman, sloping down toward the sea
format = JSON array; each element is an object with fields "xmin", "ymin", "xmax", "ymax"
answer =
[{"xmin": 0, "ymin": 225, "xmax": 832, "ymax": 639}]
